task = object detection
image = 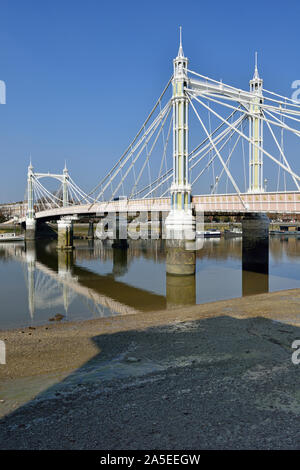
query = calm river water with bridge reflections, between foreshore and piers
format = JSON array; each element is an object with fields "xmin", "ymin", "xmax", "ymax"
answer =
[{"xmin": 0, "ymin": 236, "xmax": 300, "ymax": 329}]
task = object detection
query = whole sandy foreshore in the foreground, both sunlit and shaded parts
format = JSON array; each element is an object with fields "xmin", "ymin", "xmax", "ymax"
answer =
[{"xmin": 0, "ymin": 290, "xmax": 300, "ymax": 449}]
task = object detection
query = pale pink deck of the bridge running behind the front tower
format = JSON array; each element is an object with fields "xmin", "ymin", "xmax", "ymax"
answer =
[{"xmin": 20, "ymin": 191, "xmax": 300, "ymax": 223}]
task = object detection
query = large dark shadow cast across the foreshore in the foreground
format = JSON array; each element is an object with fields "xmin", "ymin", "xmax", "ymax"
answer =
[{"xmin": 0, "ymin": 316, "xmax": 300, "ymax": 450}]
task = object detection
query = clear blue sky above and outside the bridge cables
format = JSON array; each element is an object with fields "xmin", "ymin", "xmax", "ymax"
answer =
[{"xmin": 0, "ymin": 0, "xmax": 300, "ymax": 202}]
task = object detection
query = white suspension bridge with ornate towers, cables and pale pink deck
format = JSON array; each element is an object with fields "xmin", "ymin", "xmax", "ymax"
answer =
[{"xmin": 20, "ymin": 29, "xmax": 300, "ymax": 244}]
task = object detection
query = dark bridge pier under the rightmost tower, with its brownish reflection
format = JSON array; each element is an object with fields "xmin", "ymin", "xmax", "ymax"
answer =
[{"xmin": 242, "ymin": 213, "xmax": 270, "ymax": 295}]
